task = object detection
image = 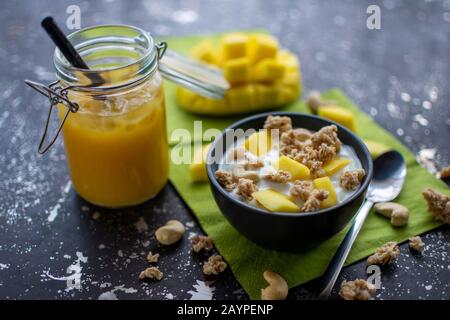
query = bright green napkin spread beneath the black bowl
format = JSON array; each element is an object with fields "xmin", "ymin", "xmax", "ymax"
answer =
[{"xmin": 166, "ymin": 33, "xmax": 448, "ymax": 299}]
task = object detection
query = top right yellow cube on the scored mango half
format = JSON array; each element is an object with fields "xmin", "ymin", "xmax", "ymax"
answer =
[{"xmin": 247, "ymin": 33, "xmax": 278, "ymax": 64}]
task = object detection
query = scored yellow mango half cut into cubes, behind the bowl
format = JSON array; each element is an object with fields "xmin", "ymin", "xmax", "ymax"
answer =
[{"xmin": 176, "ymin": 33, "xmax": 303, "ymax": 116}]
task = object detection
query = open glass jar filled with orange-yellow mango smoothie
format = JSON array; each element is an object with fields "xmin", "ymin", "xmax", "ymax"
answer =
[{"xmin": 54, "ymin": 26, "xmax": 168, "ymax": 208}]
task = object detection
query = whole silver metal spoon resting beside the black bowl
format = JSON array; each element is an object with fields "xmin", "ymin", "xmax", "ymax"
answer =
[{"xmin": 317, "ymin": 151, "xmax": 406, "ymax": 300}]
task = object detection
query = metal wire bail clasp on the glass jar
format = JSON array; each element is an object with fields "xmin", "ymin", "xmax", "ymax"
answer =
[{"xmin": 24, "ymin": 41, "xmax": 167, "ymax": 154}]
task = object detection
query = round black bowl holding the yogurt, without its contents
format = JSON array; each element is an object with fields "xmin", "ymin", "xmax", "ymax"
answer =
[{"xmin": 207, "ymin": 112, "xmax": 373, "ymax": 252}]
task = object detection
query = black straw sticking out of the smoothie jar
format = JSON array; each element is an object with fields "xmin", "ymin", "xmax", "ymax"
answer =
[{"xmin": 41, "ymin": 17, "xmax": 104, "ymax": 85}]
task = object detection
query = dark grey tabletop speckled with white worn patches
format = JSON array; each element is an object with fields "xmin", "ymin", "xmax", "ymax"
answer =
[{"xmin": 0, "ymin": 0, "xmax": 450, "ymax": 299}]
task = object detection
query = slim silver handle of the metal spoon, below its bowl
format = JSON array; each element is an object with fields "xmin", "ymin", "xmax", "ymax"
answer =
[{"xmin": 317, "ymin": 199, "xmax": 373, "ymax": 300}]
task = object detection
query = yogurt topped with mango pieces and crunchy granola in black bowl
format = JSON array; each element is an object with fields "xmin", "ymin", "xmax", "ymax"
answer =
[{"xmin": 215, "ymin": 115, "xmax": 366, "ymax": 213}]
